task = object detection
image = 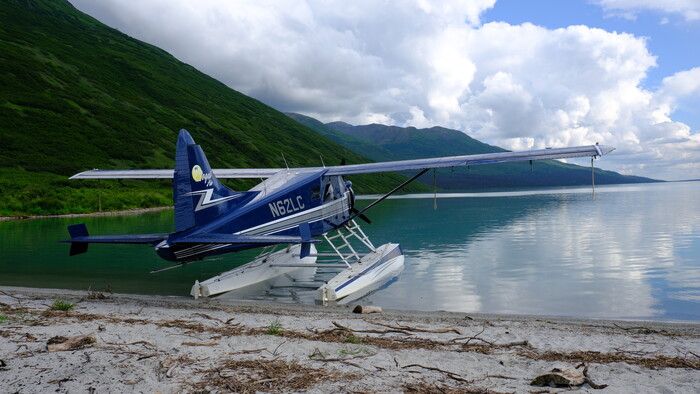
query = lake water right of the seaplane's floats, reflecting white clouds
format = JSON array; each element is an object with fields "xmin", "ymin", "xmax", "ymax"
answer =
[{"xmin": 358, "ymin": 186, "xmax": 700, "ymax": 319}]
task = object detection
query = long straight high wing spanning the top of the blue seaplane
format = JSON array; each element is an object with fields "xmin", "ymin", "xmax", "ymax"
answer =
[{"xmin": 70, "ymin": 145, "xmax": 615, "ymax": 179}]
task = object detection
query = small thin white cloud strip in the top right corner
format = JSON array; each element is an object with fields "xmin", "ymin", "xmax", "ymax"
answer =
[{"xmin": 595, "ymin": 0, "xmax": 700, "ymax": 23}]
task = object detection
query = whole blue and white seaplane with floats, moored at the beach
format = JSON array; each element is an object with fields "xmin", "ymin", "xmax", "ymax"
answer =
[{"xmin": 62, "ymin": 129, "xmax": 614, "ymax": 304}]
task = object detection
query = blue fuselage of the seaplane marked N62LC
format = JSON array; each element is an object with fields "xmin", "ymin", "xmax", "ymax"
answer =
[{"xmin": 156, "ymin": 170, "xmax": 354, "ymax": 262}]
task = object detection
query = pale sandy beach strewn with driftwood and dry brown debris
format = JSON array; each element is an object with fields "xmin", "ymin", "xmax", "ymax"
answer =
[{"xmin": 0, "ymin": 287, "xmax": 700, "ymax": 393}]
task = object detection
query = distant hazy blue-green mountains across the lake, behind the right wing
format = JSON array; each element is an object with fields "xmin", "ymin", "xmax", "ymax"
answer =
[{"xmin": 287, "ymin": 114, "xmax": 655, "ymax": 190}]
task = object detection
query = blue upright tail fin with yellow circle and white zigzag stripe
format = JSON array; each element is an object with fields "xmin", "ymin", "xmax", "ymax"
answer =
[{"xmin": 173, "ymin": 129, "xmax": 255, "ymax": 231}]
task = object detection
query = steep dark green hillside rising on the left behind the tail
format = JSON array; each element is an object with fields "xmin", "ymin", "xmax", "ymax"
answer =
[{"xmin": 0, "ymin": 0, "xmax": 412, "ymax": 215}]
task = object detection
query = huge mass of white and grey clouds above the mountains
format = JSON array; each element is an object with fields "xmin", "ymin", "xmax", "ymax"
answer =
[{"xmin": 74, "ymin": 0, "xmax": 700, "ymax": 179}]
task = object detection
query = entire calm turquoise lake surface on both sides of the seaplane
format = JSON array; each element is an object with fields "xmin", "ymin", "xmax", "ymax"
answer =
[{"xmin": 0, "ymin": 182, "xmax": 700, "ymax": 321}]
